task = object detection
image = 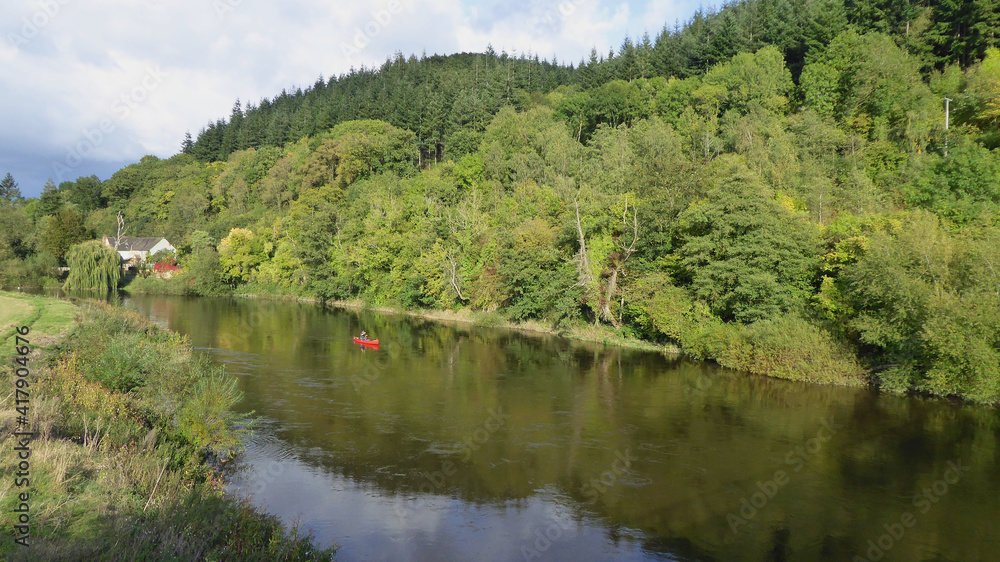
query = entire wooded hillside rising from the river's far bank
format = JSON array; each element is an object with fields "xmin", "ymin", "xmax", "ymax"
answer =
[{"xmin": 0, "ymin": 0, "xmax": 1000, "ymax": 403}]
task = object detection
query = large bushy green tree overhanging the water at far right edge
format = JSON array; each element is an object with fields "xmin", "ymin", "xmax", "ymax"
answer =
[{"xmin": 844, "ymin": 211, "xmax": 1000, "ymax": 402}]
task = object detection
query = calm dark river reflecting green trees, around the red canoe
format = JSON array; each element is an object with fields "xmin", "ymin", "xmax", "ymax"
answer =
[{"xmin": 119, "ymin": 295, "xmax": 1000, "ymax": 561}]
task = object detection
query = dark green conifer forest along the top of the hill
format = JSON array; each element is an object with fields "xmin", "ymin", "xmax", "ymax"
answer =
[{"xmin": 185, "ymin": 0, "xmax": 1000, "ymax": 161}]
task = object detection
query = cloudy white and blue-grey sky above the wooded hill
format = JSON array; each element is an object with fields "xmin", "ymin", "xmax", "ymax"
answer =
[{"xmin": 0, "ymin": 0, "xmax": 702, "ymax": 197}]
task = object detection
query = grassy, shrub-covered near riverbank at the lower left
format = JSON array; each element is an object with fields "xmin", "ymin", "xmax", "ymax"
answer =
[{"xmin": 0, "ymin": 293, "xmax": 333, "ymax": 560}]
